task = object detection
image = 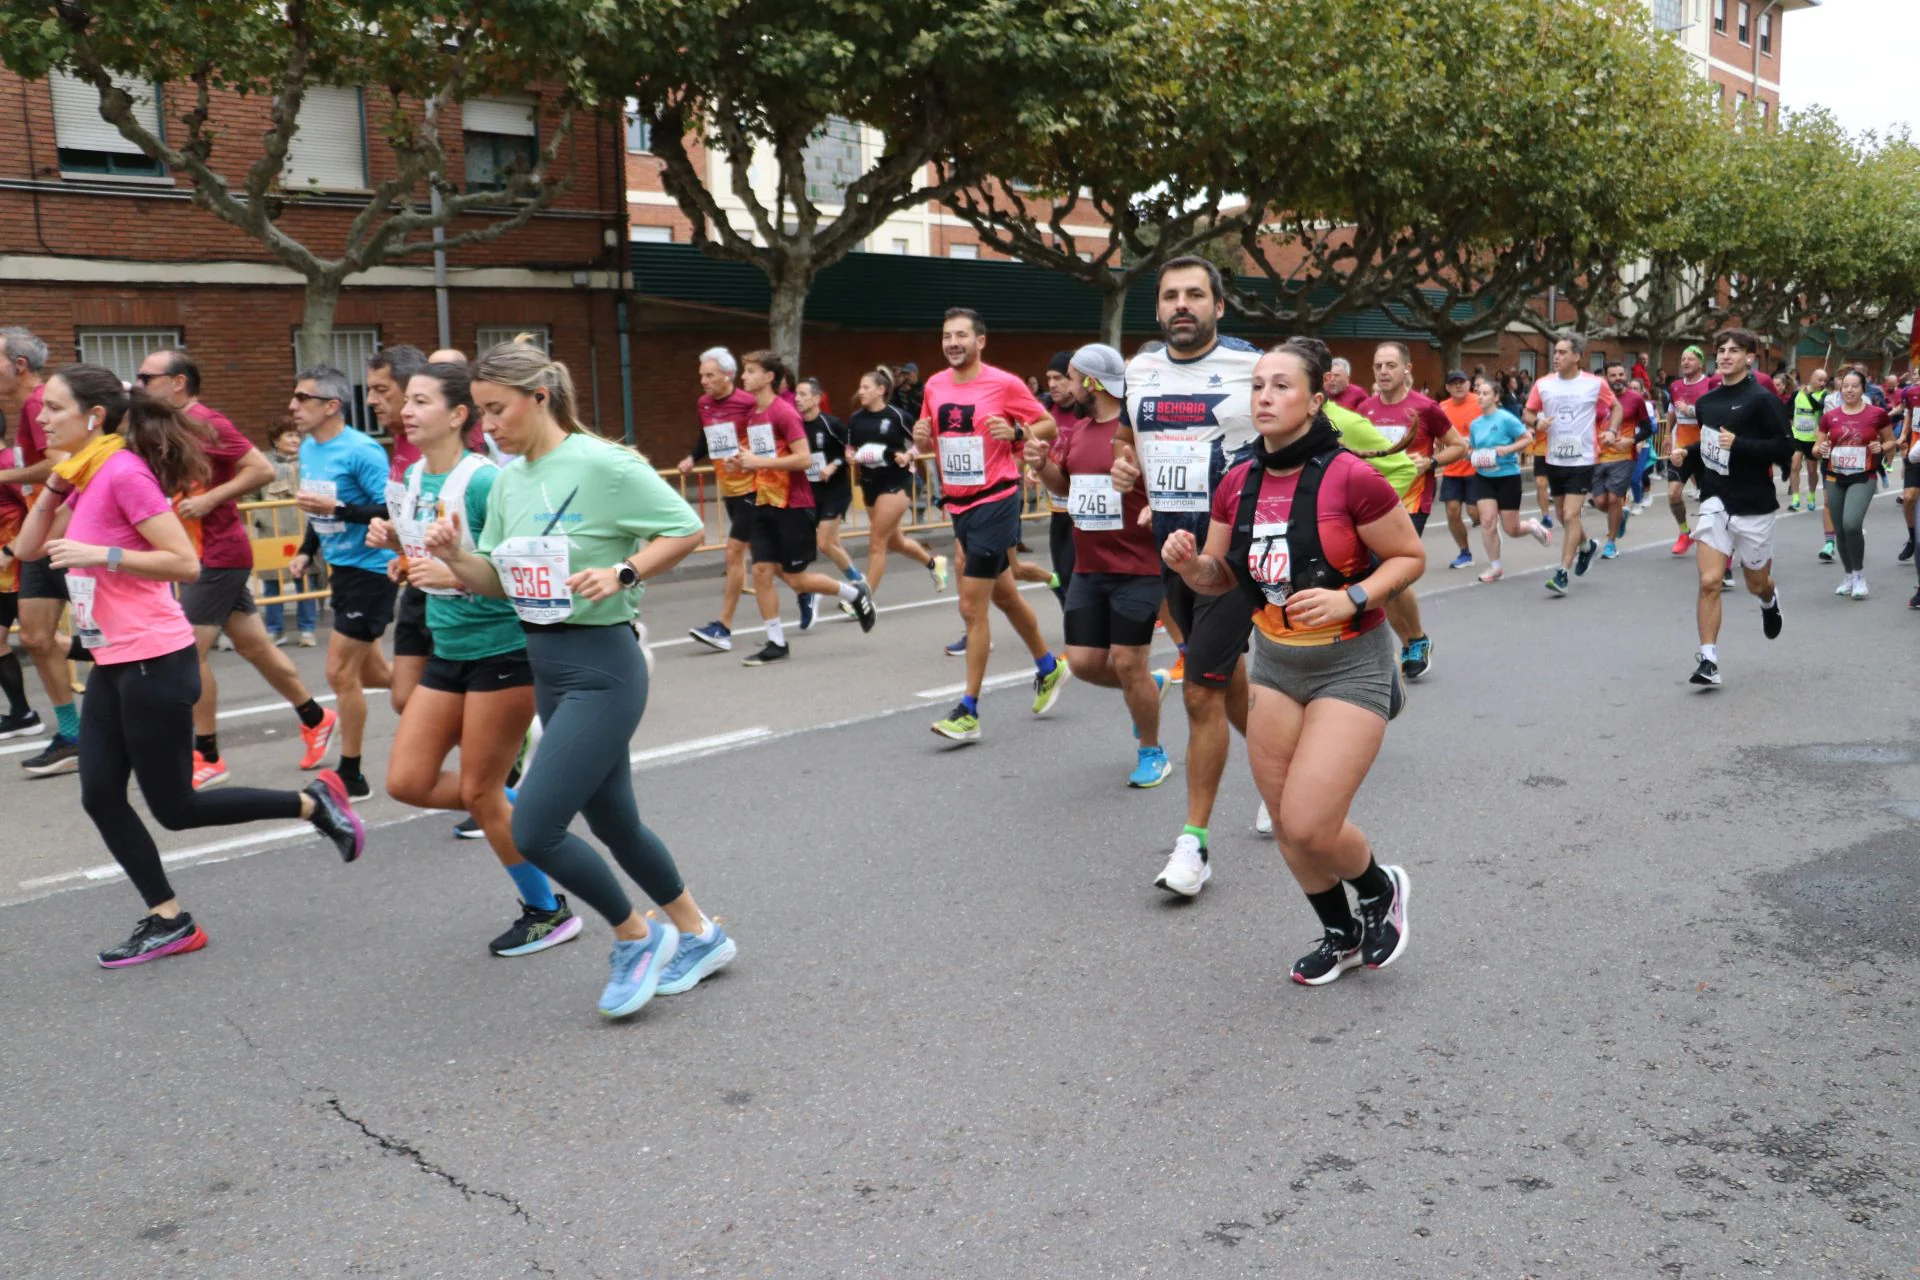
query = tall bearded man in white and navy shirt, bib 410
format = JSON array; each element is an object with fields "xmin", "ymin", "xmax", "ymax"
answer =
[{"xmin": 1114, "ymin": 257, "xmax": 1265, "ymax": 898}]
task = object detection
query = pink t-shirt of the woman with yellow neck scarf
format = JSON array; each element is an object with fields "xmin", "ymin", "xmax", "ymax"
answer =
[{"xmin": 65, "ymin": 449, "xmax": 194, "ymax": 666}]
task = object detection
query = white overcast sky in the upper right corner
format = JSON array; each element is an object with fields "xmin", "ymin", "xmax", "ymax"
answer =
[{"xmin": 1780, "ymin": 0, "xmax": 1920, "ymax": 134}]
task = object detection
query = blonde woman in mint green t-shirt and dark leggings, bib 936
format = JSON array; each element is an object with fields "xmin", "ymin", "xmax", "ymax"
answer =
[{"xmin": 426, "ymin": 344, "xmax": 735, "ymax": 1017}]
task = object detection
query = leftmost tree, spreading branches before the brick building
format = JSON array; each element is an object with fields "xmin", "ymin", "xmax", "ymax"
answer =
[{"xmin": 0, "ymin": 0, "xmax": 612, "ymax": 365}]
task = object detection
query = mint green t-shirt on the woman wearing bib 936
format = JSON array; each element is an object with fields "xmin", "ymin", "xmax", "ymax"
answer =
[{"xmin": 476, "ymin": 434, "xmax": 705, "ymax": 628}]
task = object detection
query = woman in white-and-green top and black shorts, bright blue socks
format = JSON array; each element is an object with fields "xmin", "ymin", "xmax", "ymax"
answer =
[{"xmin": 367, "ymin": 365, "xmax": 580, "ymax": 956}]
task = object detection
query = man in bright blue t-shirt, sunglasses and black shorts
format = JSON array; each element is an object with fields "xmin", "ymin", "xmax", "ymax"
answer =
[{"xmin": 286, "ymin": 365, "xmax": 394, "ymax": 800}]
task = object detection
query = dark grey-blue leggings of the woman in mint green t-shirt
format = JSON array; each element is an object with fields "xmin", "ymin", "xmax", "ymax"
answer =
[{"xmin": 513, "ymin": 626, "xmax": 685, "ymax": 925}]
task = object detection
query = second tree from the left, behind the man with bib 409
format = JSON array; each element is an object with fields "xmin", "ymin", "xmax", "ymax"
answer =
[{"xmin": 622, "ymin": 0, "xmax": 1131, "ymax": 361}]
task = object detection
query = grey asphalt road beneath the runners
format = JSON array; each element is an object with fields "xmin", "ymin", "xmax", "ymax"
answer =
[{"xmin": 0, "ymin": 501, "xmax": 1920, "ymax": 1280}]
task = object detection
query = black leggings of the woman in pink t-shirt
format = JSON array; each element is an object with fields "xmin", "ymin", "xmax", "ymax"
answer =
[{"xmin": 81, "ymin": 645, "xmax": 300, "ymax": 908}]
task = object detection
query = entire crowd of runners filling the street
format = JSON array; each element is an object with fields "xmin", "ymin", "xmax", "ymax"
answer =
[{"xmin": 0, "ymin": 257, "xmax": 1920, "ymax": 1017}]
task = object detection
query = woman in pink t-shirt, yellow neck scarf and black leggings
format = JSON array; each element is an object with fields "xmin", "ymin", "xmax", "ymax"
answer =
[{"xmin": 17, "ymin": 365, "xmax": 365, "ymax": 969}]
